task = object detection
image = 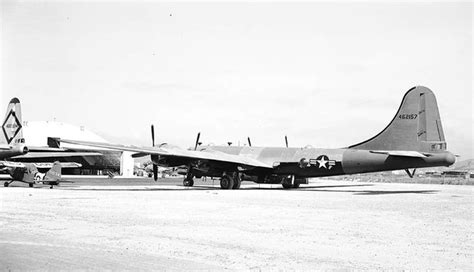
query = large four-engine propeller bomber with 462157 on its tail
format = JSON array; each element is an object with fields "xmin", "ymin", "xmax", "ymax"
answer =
[{"xmin": 59, "ymin": 86, "xmax": 455, "ymax": 189}]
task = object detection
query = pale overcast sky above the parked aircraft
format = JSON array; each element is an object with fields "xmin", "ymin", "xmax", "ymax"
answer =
[{"xmin": 0, "ymin": 1, "xmax": 474, "ymax": 159}]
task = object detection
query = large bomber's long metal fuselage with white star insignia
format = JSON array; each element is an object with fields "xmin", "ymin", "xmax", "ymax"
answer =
[{"xmin": 200, "ymin": 146, "xmax": 455, "ymax": 177}]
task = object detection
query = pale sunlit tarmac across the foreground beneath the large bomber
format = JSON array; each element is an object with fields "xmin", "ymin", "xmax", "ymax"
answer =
[{"xmin": 0, "ymin": 177, "xmax": 474, "ymax": 271}]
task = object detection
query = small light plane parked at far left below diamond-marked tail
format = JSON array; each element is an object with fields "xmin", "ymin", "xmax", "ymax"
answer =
[{"xmin": 0, "ymin": 161, "xmax": 81, "ymax": 189}]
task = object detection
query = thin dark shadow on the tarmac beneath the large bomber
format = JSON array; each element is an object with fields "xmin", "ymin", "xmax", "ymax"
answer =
[{"xmin": 56, "ymin": 184, "xmax": 438, "ymax": 195}]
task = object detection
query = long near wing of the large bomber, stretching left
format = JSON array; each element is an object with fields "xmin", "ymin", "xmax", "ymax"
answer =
[{"xmin": 58, "ymin": 139, "xmax": 272, "ymax": 169}]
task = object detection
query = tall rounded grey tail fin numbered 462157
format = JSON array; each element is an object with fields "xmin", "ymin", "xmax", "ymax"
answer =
[{"xmin": 349, "ymin": 86, "xmax": 447, "ymax": 152}]
